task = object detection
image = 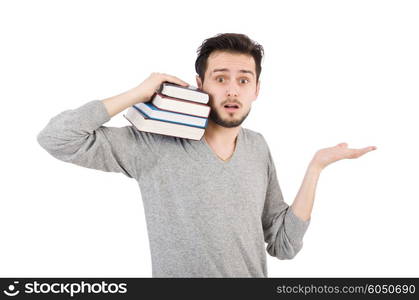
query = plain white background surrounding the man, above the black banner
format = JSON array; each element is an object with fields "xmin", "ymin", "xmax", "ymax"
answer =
[{"xmin": 0, "ymin": 0, "xmax": 419, "ymax": 277}]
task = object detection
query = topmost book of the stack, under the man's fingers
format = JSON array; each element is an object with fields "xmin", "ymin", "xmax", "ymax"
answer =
[{"xmin": 158, "ymin": 82, "xmax": 209, "ymax": 104}]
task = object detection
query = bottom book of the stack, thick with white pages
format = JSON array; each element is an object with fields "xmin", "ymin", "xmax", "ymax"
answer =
[{"xmin": 124, "ymin": 106, "xmax": 205, "ymax": 140}]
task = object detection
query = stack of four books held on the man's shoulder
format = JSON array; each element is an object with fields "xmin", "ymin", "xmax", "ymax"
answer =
[{"xmin": 124, "ymin": 82, "xmax": 211, "ymax": 140}]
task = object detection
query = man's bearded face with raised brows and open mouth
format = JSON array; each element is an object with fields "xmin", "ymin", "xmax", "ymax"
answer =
[{"xmin": 196, "ymin": 51, "xmax": 260, "ymax": 128}]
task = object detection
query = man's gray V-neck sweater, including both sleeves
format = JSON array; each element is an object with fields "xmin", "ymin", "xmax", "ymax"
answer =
[{"xmin": 37, "ymin": 100, "xmax": 310, "ymax": 277}]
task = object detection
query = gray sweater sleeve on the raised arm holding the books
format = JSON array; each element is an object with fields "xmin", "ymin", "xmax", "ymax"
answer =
[{"xmin": 37, "ymin": 100, "xmax": 159, "ymax": 179}]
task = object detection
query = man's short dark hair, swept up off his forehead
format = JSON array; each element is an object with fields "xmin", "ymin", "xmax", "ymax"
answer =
[{"xmin": 195, "ymin": 33, "xmax": 264, "ymax": 82}]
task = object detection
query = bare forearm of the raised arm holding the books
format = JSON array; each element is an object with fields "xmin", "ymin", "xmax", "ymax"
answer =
[{"xmin": 102, "ymin": 86, "xmax": 148, "ymax": 118}]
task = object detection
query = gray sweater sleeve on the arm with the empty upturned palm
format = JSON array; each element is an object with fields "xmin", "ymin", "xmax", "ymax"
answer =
[{"xmin": 262, "ymin": 149, "xmax": 310, "ymax": 259}]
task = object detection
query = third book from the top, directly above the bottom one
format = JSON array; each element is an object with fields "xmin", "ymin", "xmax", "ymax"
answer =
[{"xmin": 135, "ymin": 102, "xmax": 207, "ymax": 128}]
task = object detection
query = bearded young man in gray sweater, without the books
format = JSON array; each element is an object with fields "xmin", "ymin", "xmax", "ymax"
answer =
[{"xmin": 38, "ymin": 34, "xmax": 373, "ymax": 277}]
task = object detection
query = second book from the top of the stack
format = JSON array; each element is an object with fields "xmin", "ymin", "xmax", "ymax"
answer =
[{"xmin": 151, "ymin": 94, "xmax": 211, "ymax": 118}]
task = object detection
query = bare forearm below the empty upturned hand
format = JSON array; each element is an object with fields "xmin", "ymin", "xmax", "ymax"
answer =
[{"xmin": 291, "ymin": 162, "xmax": 321, "ymax": 221}]
